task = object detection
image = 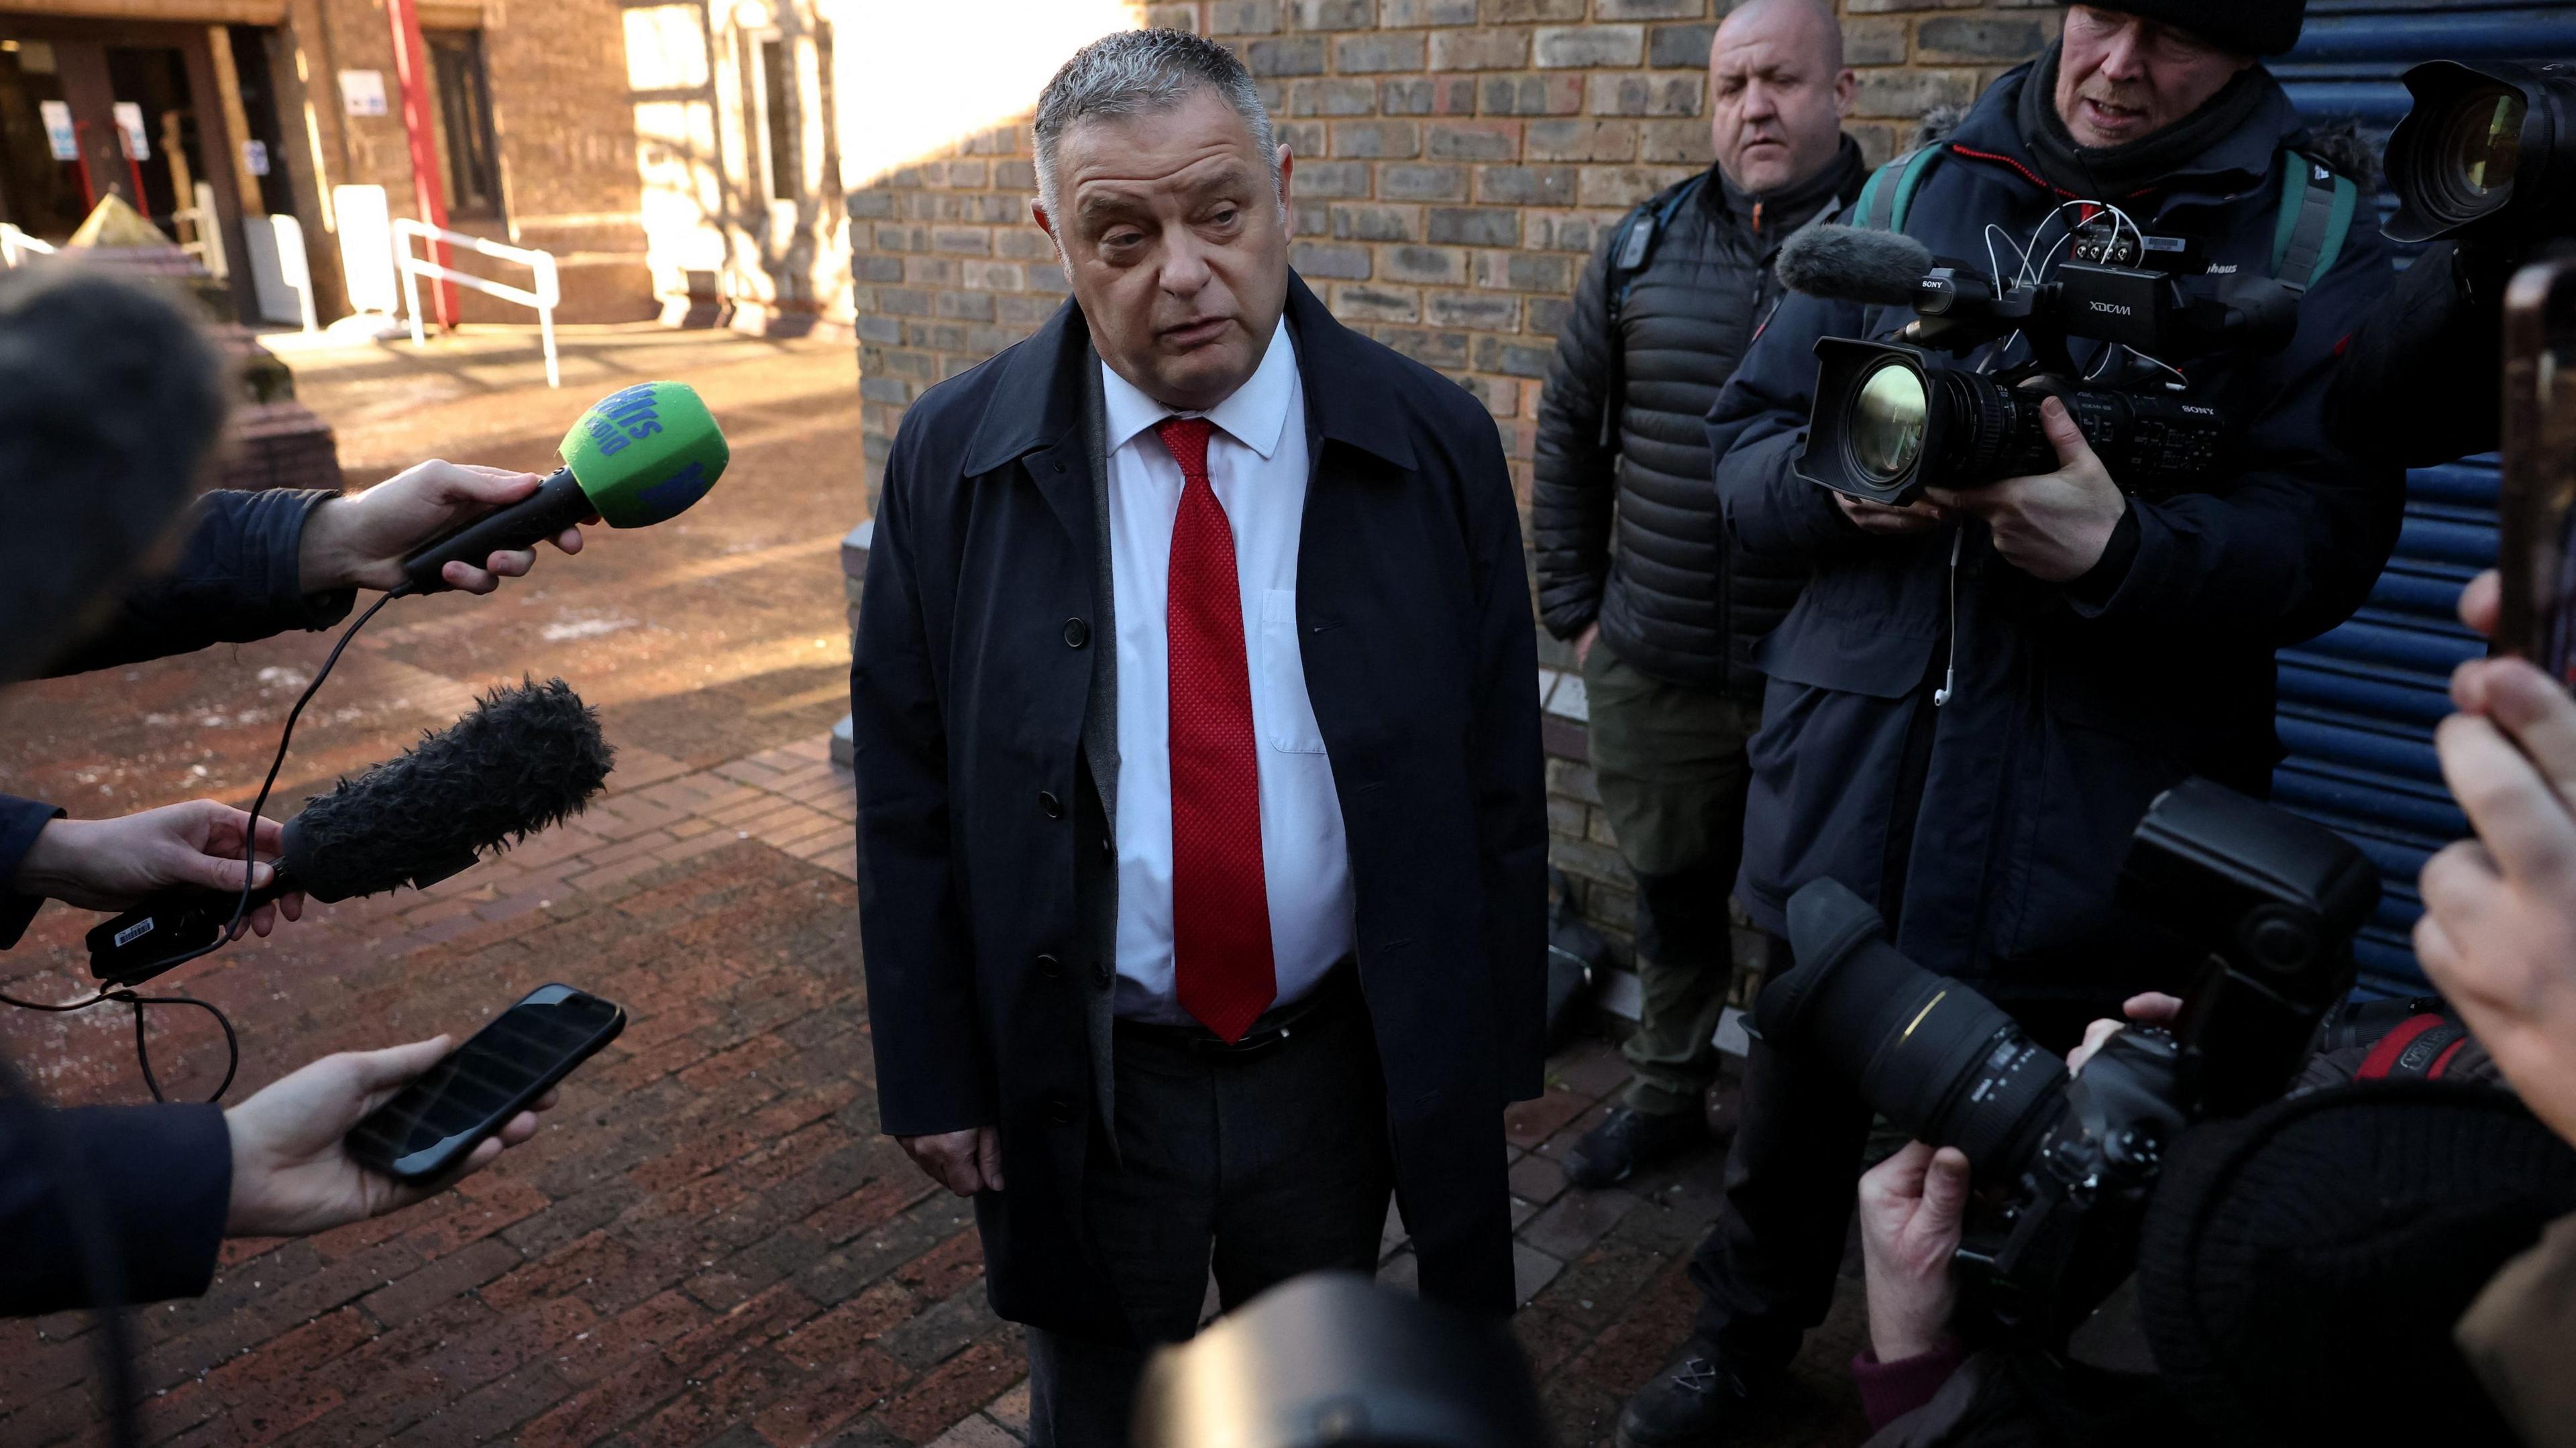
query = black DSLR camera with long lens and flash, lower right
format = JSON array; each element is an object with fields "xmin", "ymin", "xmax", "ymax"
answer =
[{"xmin": 1754, "ymin": 778, "xmax": 2380, "ymax": 1345}]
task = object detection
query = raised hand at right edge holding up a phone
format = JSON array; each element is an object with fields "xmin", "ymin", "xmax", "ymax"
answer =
[{"xmin": 2414, "ymin": 572, "xmax": 2576, "ymax": 1141}]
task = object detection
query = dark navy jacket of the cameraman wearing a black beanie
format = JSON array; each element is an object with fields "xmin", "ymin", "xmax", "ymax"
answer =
[{"xmin": 1708, "ymin": 64, "xmax": 2404, "ymax": 992}]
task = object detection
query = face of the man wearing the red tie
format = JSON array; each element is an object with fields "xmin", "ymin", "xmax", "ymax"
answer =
[{"xmin": 1033, "ymin": 90, "xmax": 1291, "ymax": 410}]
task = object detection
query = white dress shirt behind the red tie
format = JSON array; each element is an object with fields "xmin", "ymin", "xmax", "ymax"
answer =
[{"xmin": 1100, "ymin": 319, "xmax": 1352, "ymax": 1025}]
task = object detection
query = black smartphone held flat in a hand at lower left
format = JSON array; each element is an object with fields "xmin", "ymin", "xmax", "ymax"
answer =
[{"xmin": 347, "ymin": 985, "xmax": 626, "ymax": 1182}]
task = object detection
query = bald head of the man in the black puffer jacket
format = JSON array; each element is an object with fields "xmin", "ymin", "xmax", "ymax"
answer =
[{"xmin": 1708, "ymin": 0, "xmax": 1855, "ymax": 196}]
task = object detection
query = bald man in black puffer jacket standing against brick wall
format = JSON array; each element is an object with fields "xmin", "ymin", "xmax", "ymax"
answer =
[{"xmin": 1530, "ymin": 0, "xmax": 1868, "ymax": 1185}]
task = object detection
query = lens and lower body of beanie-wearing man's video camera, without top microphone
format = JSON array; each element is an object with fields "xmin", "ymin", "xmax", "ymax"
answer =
[{"xmin": 1795, "ymin": 337, "xmax": 2226, "ymax": 508}]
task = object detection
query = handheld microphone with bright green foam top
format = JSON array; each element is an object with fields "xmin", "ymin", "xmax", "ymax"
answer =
[{"xmin": 396, "ymin": 382, "xmax": 732, "ymax": 593}]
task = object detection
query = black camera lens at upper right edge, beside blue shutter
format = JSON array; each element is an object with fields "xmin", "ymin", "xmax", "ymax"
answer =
[{"xmin": 2385, "ymin": 59, "xmax": 2576, "ymax": 242}]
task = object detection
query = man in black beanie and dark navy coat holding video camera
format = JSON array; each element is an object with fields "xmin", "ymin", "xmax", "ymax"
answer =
[{"xmin": 1623, "ymin": 0, "xmax": 2404, "ymax": 1445}]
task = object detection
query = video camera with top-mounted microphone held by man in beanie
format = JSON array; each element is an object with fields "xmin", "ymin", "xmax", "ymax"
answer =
[{"xmin": 1782, "ymin": 211, "xmax": 2298, "ymax": 505}]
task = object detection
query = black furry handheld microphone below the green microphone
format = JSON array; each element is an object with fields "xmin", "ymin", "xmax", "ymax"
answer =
[{"xmin": 88, "ymin": 677, "xmax": 613, "ymax": 985}]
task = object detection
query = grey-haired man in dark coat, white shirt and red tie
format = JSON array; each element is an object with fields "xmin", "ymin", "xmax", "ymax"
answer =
[{"xmin": 850, "ymin": 31, "xmax": 1546, "ymax": 1445}]
